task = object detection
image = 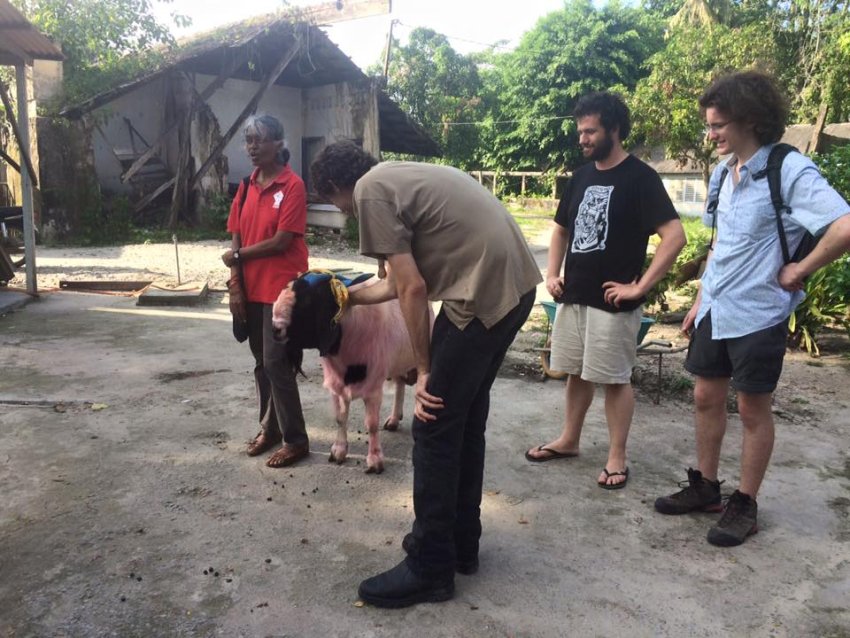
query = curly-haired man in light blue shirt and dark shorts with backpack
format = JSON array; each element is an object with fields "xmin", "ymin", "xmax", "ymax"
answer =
[{"xmin": 655, "ymin": 72, "xmax": 850, "ymax": 547}]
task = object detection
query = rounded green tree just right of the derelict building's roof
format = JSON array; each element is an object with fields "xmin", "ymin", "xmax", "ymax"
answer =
[{"xmin": 380, "ymin": 28, "xmax": 482, "ymax": 168}]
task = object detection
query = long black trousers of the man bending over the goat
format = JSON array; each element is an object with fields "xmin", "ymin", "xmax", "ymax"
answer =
[{"xmin": 404, "ymin": 290, "xmax": 535, "ymax": 577}]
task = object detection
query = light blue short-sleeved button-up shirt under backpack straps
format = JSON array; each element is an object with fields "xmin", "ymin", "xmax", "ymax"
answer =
[{"xmin": 696, "ymin": 145, "xmax": 850, "ymax": 339}]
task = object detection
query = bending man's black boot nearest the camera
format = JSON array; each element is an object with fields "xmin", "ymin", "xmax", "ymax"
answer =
[{"xmin": 357, "ymin": 560, "xmax": 455, "ymax": 609}]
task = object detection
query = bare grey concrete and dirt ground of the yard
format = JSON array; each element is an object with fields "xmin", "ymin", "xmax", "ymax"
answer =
[{"xmin": 0, "ymin": 236, "xmax": 850, "ymax": 638}]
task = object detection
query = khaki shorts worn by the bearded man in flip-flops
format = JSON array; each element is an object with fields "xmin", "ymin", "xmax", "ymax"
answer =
[{"xmin": 549, "ymin": 304, "xmax": 643, "ymax": 384}]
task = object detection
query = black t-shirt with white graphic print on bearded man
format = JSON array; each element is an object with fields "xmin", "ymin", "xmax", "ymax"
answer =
[{"xmin": 555, "ymin": 155, "xmax": 678, "ymax": 312}]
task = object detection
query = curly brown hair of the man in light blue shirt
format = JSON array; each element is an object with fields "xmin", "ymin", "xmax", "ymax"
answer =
[{"xmin": 699, "ymin": 71, "xmax": 788, "ymax": 145}]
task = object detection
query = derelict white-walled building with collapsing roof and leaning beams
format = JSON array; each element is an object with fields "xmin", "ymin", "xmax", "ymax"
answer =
[{"xmin": 63, "ymin": 16, "xmax": 440, "ymax": 232}]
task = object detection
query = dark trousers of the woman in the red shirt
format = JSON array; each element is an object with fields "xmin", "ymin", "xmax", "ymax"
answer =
[{"xmin": 243, "ymin": 302, "xmax": 307, "ymax": 445}]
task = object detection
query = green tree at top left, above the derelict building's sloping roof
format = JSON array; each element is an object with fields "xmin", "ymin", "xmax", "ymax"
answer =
[{"xmin": 13, "ymin": 0, "xmax": 189, "ymax": 102}]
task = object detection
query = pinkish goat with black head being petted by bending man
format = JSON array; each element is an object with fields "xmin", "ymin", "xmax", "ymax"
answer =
[{"xmin": 272, "ymin": 272, "xmax": 434, "ymax": 474}]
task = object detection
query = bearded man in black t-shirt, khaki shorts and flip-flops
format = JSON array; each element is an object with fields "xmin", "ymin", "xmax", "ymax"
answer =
[{"xmin": 525, "ymin": 93, "xmax": 686, "ymax": 490}]
